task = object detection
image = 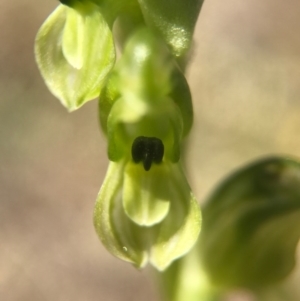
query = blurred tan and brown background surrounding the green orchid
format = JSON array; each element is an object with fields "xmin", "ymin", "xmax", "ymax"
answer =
[{"xmin": 0, "ymin": 0, "xmax": 300, "ymax": 301}]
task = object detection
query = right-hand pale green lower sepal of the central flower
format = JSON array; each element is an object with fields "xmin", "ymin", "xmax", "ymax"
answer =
[{"xmin": 150, "ymin": 164, "xmax": 201, "ymax": 271}]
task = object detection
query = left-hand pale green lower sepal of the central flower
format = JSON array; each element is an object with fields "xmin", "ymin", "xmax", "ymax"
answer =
[{"xmin": 94, "ymin": 161, "xmax": 148, "ymax": 267}]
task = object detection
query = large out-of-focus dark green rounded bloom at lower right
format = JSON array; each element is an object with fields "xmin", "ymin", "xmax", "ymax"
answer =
[{"xmin": 200, "ymin": 157, "xmax": 300, "ymax": 289}]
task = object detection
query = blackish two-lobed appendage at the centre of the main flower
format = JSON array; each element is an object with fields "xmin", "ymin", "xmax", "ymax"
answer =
[{"xmin": 131, "ymin": 136, "xmax": 164, "ymax": 171}]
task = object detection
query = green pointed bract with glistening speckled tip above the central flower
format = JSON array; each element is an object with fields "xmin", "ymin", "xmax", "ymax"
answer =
[{"xmin": 138, "ymin": 0, "xmax": 203, "ymax": 57}]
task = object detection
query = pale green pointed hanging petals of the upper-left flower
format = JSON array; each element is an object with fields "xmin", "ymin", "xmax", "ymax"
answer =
[{"xmin": 35, "ymin": 5, "xmax": 115, "ymax": 111}]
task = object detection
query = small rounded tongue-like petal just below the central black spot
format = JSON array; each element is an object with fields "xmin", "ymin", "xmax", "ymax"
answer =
[{"xmin": 123, "ymin": 163, "xmax": 171, "ymax": 226}]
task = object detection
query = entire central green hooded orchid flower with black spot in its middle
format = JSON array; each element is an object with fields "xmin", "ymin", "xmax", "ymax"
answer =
[{"xmin": 94, "ymin": 28, "xmax": 201, "ymax": 270}]
